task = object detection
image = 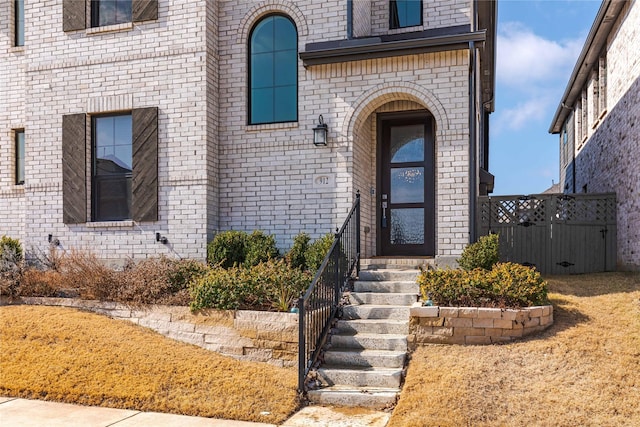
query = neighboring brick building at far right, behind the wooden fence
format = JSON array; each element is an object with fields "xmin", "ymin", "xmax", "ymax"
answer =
[{"xmin": 549, "ymin": 0, "xmax": 640, "ymax": 269}]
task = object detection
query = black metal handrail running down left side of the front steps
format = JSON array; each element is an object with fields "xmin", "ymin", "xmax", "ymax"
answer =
[{"xmin": 298, "ymin": 192, "xmax": 360, "ymax": 393}]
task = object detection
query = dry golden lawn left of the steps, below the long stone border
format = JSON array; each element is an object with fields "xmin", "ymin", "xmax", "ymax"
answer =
[{"xmin": 0, "ymin": 306, "xmax": 298, "ymax": 423}]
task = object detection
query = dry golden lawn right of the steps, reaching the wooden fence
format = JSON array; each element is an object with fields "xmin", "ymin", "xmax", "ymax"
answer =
[{"xmin": 389, "ymin": 273, "xmax": 640, "ymax": 427}]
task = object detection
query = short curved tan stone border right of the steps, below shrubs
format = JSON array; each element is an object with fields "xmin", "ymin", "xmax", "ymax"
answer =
[{"xmin": 409, "ymin": 303, "xmax": 553, "ymax": 349}]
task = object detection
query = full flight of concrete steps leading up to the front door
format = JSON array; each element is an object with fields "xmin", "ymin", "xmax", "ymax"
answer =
[{"xmin": 308, "ymin": 259, "xmax": 424, "ymax": 409}]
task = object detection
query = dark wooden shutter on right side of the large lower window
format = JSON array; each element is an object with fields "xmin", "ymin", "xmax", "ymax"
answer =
[{"xmin": 131, "ymin": 107, "xmax": 158, "ymax": 221}]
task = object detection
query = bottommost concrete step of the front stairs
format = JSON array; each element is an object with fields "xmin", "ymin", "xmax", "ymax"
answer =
[{"xmin": 307, "ymin": 385, "xmax": 400, "ymax": 409}]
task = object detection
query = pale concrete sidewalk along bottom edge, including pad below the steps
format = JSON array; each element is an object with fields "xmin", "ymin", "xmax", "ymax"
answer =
[{"xmin": 0, "ymin": 397, "xmax": 390, "ymax": 427}]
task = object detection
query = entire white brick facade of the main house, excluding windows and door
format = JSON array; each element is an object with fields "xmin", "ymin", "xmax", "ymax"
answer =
[{"xmin": 0, "ymin": 0, "xmax": 480, "ymax": 259}]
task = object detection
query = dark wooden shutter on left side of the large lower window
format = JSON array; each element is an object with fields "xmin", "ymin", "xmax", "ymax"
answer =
[{"xmin": 62, "ymin": 114, "xmax": 87, "ymax": 224}]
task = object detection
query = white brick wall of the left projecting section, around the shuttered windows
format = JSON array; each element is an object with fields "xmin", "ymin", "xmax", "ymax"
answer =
[{"xmin": 0, "ymin": 0, "xmax": 217, "ymax": 259}]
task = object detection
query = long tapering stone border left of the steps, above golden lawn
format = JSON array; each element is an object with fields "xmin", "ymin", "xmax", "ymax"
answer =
[{"xmin": 0, "ymin": 297, "xmax": 298, "ymax": 367}]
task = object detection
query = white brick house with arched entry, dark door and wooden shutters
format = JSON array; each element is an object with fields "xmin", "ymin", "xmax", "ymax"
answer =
[{"xmin": 0, "ymin": 0, "xmax": 496, "ymax": 262}]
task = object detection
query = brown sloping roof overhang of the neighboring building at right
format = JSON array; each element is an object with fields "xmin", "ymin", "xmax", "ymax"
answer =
[{"xmin": 549, "ymin": 0, "xmax": 626, "ymax": 134}]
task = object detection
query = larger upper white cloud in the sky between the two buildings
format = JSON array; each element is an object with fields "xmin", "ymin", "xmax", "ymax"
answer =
[{"xmin": 497, "ymin": 22, "xmax": 583, "ymax": 90}]
